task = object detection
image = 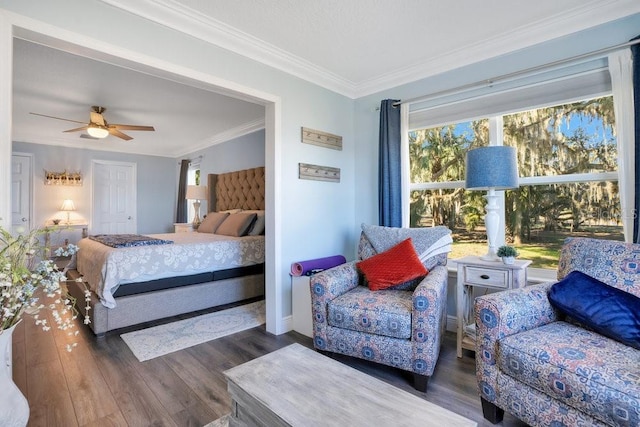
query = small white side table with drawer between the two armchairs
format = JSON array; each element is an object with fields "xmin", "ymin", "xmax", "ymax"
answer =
[{"xmin": 456, "ymin": 256, "xmax": 531, "ymax": 357}]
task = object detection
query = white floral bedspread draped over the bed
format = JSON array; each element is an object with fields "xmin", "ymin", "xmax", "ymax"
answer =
[{"xmin": 77, "ymin": 233, "xmax": 264, "ymax": 308}]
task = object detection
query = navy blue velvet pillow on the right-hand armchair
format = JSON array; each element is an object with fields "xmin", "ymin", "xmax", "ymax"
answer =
[{"xmin": 549, "ymin": 271, "xmax": 640, "ymax": 350}]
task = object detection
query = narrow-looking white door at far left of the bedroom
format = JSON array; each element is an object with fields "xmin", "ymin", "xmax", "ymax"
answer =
[{"xmin": 11, "ymin": 154, "xmax": 31, "ymax": 232}]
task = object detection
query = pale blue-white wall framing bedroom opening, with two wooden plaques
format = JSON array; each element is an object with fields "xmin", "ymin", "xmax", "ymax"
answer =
[{"xmin": 0, "ymin": 0, "xmax": 358, "ymax": 332}]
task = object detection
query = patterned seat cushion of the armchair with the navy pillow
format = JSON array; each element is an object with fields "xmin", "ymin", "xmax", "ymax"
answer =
[{"xmin": 497, "ymin": 322, "xmax": 640, "ymax": 425}]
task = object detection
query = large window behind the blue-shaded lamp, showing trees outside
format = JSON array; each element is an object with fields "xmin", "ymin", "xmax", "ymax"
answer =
[{"xmin": 409, "ymin": 96, "xmax": 623, "ymax": 268}]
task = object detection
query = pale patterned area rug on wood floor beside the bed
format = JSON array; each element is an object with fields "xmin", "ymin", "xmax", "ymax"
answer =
[{"xmin": 120, "ymin": 300, "xmax": 265, "ymax": 362}]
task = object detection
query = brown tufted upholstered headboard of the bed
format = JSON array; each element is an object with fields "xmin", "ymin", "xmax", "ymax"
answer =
[{"xmin": 207, "ymin": 166, "xmax": 265, "ymax": 212}]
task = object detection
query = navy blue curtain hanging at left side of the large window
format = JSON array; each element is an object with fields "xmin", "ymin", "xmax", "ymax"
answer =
[{"xmin": 378, "ymin": 99, "xmax": 402, "ymax": 227}]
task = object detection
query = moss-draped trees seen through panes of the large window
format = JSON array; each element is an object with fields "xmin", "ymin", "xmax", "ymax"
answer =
[{"xmin": 409, "ymin": 97, "xmax": 620, "ymax": 244}]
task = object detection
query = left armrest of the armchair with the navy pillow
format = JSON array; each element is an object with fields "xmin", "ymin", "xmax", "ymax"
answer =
[{"xmin": 474, "ymin": 282, "xmax": 560, "ymax": 403}]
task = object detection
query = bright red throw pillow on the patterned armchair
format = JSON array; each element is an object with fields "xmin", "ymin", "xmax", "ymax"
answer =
[{"xmin": 356, "ymin": 238, "xmax": 429, "ymax": 291}]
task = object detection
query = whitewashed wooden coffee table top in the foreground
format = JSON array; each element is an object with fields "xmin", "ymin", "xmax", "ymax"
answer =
[{"xmin": 224, "ymin": 344, "xmax": 476, "ymax": 427}]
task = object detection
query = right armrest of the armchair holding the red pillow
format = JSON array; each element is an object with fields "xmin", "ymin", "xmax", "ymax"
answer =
[{"xmin": 411, "ymin": 265, "xmax": 449, "ymax": 376}]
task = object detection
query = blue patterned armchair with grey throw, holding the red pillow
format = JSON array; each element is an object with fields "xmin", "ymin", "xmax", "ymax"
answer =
[{"xmin": 310, "ymin": 225, "xmax": 451, "ymax": 392}]
